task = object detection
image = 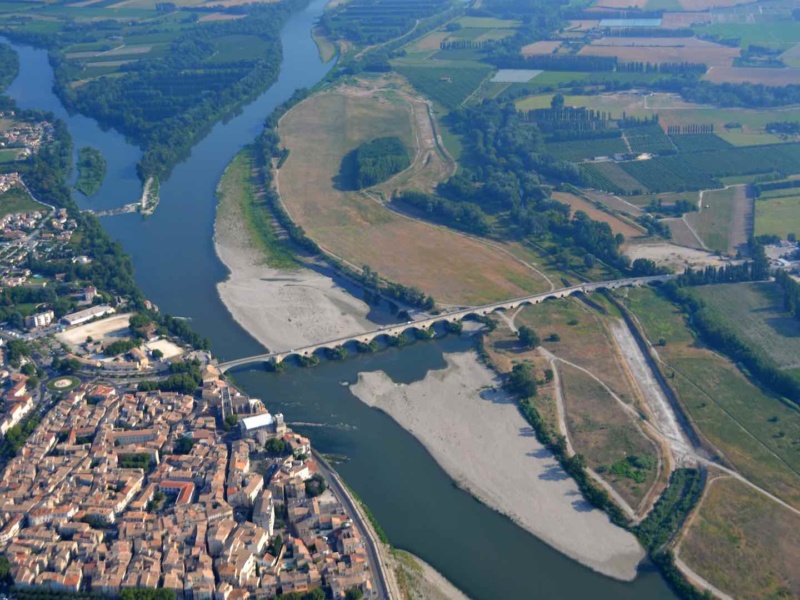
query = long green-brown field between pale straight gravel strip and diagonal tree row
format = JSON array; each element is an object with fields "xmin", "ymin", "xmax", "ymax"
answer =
[{"xmin": 624, "ymin": 288, "xmax": 800, "ymax": 507}]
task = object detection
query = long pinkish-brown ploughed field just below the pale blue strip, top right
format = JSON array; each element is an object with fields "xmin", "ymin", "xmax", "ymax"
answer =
[{"xmin": 578, "ymin": 38, "xmax": 739, "ymax": 67}]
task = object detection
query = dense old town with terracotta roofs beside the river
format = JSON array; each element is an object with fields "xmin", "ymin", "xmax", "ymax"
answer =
[{"xmin": 0, "ymin": 365, "xmax": 374, "ymax": 600}]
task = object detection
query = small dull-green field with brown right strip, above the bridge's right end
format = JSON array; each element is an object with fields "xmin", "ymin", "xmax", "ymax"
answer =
[{"xmin": 684, "ymin": 186, "xmax": 752, "ymax": 254}]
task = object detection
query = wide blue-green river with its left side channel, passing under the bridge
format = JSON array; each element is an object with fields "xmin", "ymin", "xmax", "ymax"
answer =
[{"xmin": 8, "ymin": 0, "xmax": 675, "ymax": 600}]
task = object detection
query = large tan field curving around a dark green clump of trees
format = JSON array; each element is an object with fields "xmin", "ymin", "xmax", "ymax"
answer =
[{"xmin": 279, "ymin": 88, "xmax": 546, "ymax": 304}]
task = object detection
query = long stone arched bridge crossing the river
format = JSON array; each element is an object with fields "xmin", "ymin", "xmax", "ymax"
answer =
[{"xmin": 217, "ymin": 275, "xmax": 673, "ymax": 373}]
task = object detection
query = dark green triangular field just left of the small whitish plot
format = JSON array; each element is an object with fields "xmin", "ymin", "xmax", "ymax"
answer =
[{"xmin": 396, "ymin": 66, "xmax": 491, "ymax": 109}]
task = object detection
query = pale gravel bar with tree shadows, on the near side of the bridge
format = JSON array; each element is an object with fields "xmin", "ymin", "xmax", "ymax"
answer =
[{"xmin": 351, "ymin": 352, "xmax": 644, "ymax": 581}]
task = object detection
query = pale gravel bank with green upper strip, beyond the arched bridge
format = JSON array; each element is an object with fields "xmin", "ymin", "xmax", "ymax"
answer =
[{"xmin": 214, "ymin": 150, "xmax": 374, "ymax": 351}]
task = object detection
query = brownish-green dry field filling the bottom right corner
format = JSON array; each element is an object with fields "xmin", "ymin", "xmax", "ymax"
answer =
[{"xmin": 679, "ymin": 477, "xmax": 800, "ymax": 598}]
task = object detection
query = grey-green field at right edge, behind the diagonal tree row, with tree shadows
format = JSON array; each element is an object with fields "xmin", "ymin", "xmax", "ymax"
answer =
[{"xmin": 692, "ymin": 282, "xmax": 800, "ymax": 368}]
